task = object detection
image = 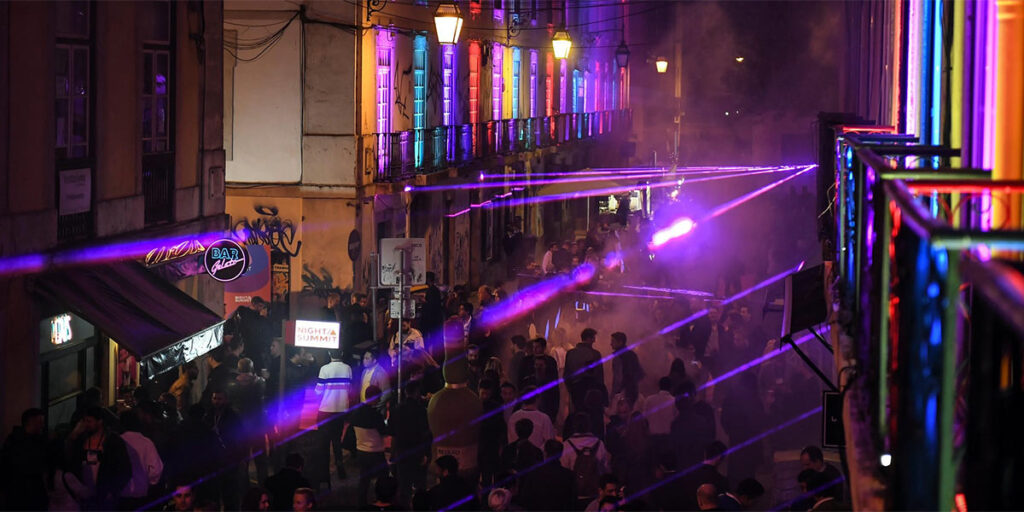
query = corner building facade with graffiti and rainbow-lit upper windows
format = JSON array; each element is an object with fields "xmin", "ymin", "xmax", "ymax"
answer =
[{"xmin": 224, "ymin": 0, "xmax": 631, "ymax": 315}]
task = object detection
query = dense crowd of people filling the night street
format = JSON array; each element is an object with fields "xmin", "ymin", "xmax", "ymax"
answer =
[{"xmin": 0, "ymin": 189, "xmax": 835, "ymax": 511}]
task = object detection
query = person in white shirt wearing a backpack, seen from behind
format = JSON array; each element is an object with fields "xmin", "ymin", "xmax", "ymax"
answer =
[{"xmin": 561, "ymin": 413, "xmax": 610, "ymax": 509}]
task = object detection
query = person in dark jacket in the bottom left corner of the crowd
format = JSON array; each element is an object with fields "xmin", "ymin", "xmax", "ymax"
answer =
[{"xmin": 0, "ymin": 408, "xmax": 48, "ymax": 510}]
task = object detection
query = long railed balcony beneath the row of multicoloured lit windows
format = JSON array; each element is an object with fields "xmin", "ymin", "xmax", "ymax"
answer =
[{"xmin": 368, "ymin": 110, "xmax": 632, "ymax": 182}]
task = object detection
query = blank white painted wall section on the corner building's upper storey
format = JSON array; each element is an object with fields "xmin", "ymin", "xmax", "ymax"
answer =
[{"xmin": 224, "ymin": 9, "xmax": 302, "ymax": 183}]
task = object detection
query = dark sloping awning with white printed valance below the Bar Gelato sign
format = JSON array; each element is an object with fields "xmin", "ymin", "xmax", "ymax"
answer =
[{"xmin": 36, "ymin": 261, "xmax": 224, "ymax": 377}]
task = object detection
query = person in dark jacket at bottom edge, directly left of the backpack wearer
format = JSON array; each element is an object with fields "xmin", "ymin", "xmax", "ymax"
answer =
[{"xmin": 519, "ymin": 439, "xmax": 577, "ymax": 510}]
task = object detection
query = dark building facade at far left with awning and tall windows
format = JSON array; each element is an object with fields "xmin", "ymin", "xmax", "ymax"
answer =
[{"xmin": 0, "ymin": 1, "xmax": 226, "ymax": 431}]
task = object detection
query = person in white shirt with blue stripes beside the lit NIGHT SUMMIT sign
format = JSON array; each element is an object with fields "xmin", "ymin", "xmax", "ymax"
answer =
[{"xmin": 314, "ymin": 349, "xmax": 352, "ymax": 480}]
